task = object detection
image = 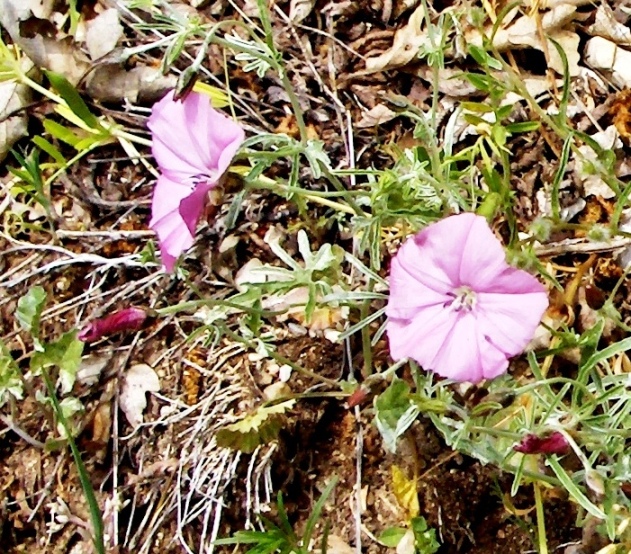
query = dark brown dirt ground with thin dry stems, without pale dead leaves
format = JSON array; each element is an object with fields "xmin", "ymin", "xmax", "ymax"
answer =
[{"xmin": 0, "ymin": 0, "xmax": 626, "ymax": 554}]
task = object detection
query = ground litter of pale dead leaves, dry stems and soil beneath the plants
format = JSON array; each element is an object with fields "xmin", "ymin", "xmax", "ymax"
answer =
[{"xmin": 0, "ymin": 0, "xmax": 631, "ymax": 553}]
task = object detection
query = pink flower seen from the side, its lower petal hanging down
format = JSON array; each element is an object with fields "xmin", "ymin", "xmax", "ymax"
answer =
[{"xmin": 147, "ymin": 92, "xmax": 245, "ymax": 271}]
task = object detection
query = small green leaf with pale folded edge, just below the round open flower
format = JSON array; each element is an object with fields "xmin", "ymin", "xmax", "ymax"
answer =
[{"xmin": 375, "ymin": 378, "xmax": 419, "ymax": 452}]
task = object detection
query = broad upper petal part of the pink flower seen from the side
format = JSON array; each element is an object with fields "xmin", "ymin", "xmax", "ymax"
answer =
[{"xmin": 147, "ymin": 92, "xmax": 245, "ymax": 181}]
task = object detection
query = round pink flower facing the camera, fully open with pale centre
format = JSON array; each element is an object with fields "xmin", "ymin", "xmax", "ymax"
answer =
[{"xmin": 386, "ymin": 213, "xmax": 548, "ymax": 383}]
